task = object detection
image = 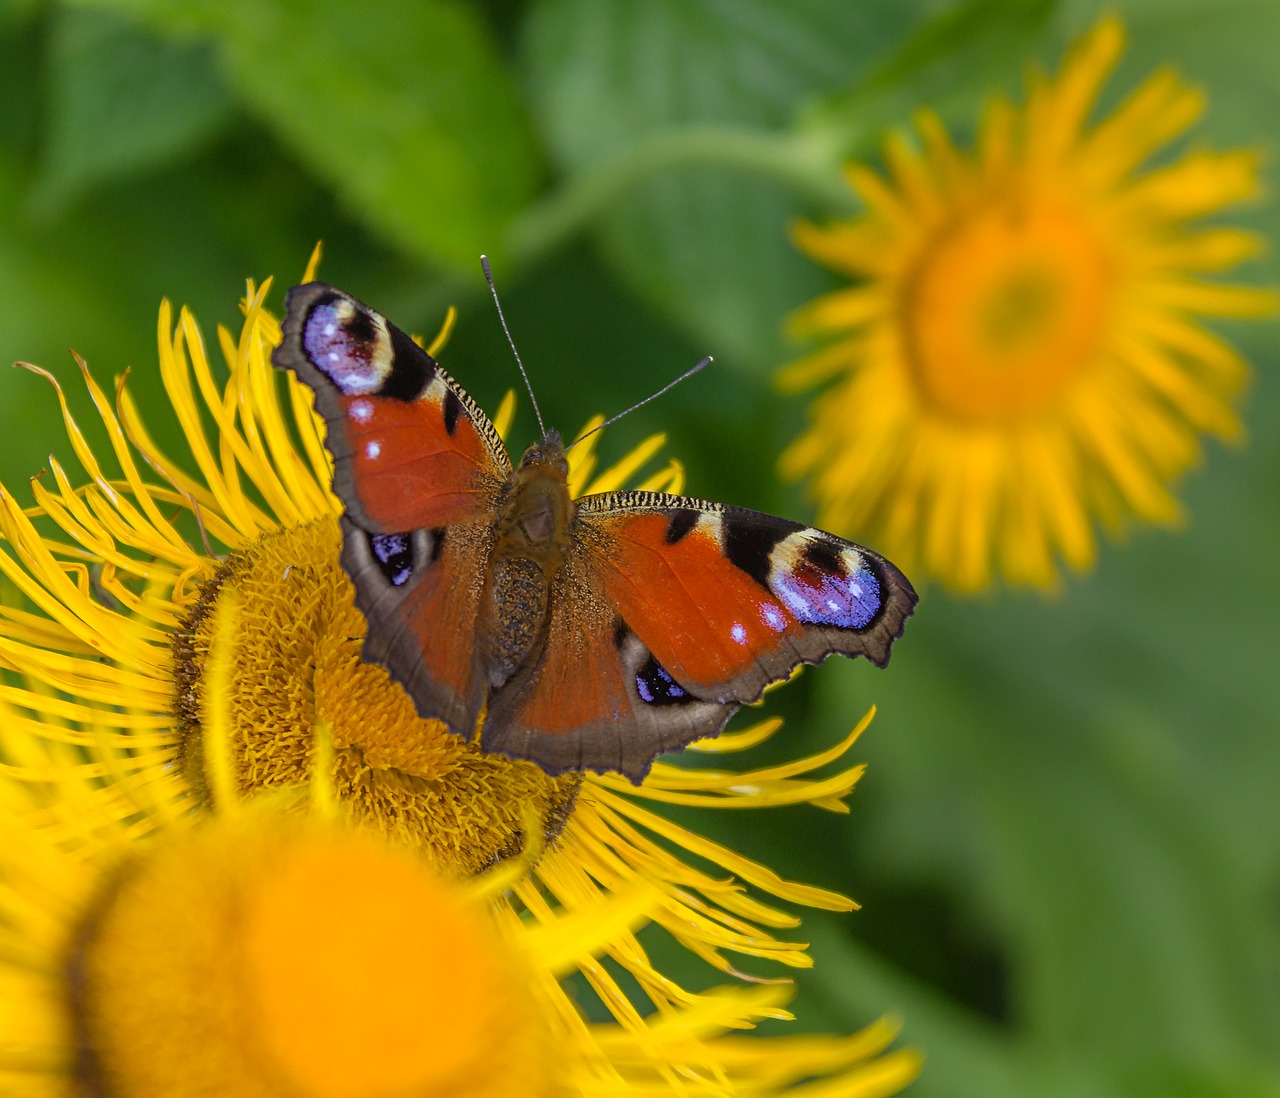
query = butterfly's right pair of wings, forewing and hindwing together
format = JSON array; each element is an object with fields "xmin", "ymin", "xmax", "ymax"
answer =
[{"xmin": 484, "ymin": 491, "xmax": 916, "ymax": 782}]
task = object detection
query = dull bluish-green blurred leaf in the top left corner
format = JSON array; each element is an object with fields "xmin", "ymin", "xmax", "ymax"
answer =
[{"xmin": 32, "ymin": 8, "xmax": 232, "ymax": 215}]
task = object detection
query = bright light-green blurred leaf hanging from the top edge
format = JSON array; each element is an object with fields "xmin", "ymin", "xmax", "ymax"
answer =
[{"xmin": 92, "ymin": 0, "xmax": 535, "ymax": 271}]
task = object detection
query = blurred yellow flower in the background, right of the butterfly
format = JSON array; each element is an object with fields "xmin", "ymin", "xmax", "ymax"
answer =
[{"xmin": 782, "ymin": 19, "xmax": 1276, "ymax": 591}]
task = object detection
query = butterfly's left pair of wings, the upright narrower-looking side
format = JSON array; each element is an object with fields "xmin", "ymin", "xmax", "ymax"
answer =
[{"xmin": 271, "ymin": 283, "xmax": 512, "ymax": 735}]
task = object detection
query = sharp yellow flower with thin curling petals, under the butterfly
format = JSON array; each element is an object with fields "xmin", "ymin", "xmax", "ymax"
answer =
[{"xmin": 0, "ymin": 263, "xmax": 872, "ymax": 1026}]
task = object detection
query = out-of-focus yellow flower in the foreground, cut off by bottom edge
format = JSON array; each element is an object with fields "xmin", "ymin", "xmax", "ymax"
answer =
[{"xmin": 0, "ymin": 721, "xmax": 919, "ymax": 1098}]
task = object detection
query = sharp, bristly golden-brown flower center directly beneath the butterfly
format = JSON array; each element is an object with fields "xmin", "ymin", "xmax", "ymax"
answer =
[{"xmin": 174, "ymin": 518, "xmax": 581, "ymax": 875}]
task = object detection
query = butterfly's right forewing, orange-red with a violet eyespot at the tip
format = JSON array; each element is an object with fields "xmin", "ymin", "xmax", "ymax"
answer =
[{"xmin": 579, "ymin": 493, "xmax": 915, "ymax": 701}]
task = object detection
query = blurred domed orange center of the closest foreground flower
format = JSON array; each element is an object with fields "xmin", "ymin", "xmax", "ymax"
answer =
[{"xmin": 68, "ymin": 816, "xmax": 554, "ymax": 1098}]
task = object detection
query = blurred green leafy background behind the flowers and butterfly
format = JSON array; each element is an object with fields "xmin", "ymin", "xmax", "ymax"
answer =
[{"xmin": 0, "ymin": 0, "xmax": 1280, "ymax": 1098}]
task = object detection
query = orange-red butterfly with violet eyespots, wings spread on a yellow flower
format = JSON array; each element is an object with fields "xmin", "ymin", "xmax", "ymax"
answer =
[{"xmin": 273, "ymin": 282, "xmax": 916, "ymax": 783}]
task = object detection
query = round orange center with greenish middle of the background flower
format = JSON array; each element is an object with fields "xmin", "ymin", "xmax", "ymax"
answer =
[{"xmin": 901, "ymin": 179, "xmax": 1115, "ymax": 421}]
